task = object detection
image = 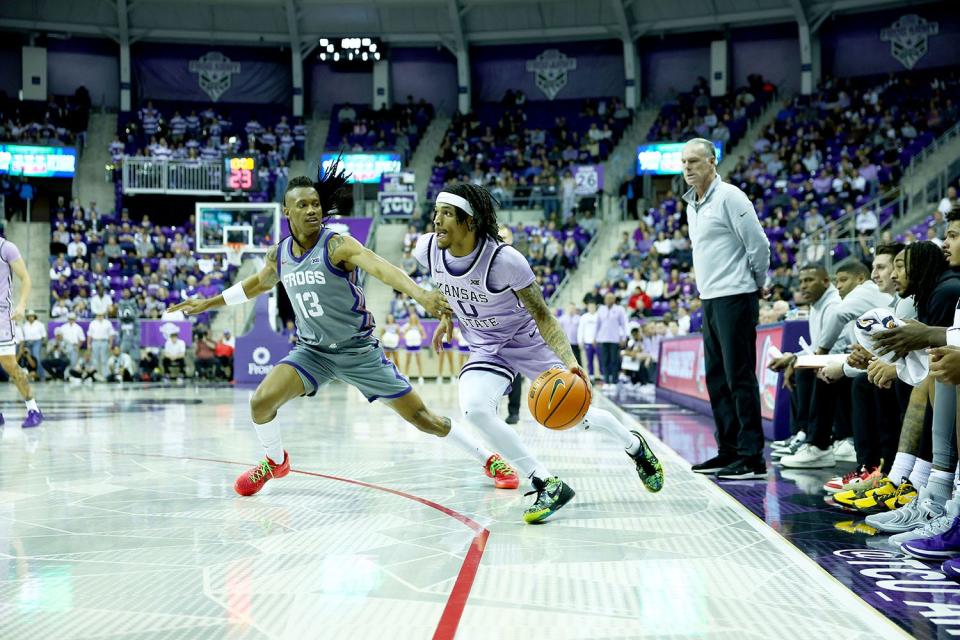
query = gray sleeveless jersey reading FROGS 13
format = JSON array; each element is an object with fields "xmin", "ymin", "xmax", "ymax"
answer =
[{"xmin": 277, "ymin": 229, "xmax": 375, "ymax": 349}]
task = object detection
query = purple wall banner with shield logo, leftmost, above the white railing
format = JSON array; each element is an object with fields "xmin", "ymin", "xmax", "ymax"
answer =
[{"xmin": 133, "ymin": 44, "xmax": 293, "ymax": 104}]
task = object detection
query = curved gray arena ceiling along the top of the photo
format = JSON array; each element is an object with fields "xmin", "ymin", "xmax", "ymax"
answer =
[{"xmin": 0, "ymin": 0, "xmax": 931, "ymax": 53}]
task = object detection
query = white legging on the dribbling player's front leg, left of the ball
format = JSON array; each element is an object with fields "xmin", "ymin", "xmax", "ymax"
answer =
[{"xmin": 458, "ymin": 369, "xmax": 552, "ymax": 478}]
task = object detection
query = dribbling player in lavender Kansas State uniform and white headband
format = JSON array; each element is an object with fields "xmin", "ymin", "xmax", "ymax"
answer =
[{"xmin": 413, "ymin": 183, "xmax": 663, "ymax": 523}]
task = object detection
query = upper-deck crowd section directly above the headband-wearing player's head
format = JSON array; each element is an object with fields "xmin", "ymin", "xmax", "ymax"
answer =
[{"xmin": 427, "ymin": 91, "xmax": 633, "ymax": 222}]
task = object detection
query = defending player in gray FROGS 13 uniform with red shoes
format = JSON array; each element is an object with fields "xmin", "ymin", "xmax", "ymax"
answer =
[{"xmin": 170, "ymin": 163, "xmax": 519, "ymax": 496}]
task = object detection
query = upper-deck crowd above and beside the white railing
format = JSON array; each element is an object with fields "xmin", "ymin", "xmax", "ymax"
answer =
[{"xmin": 110, "ymin": 100, "xmax": 307, "ymax": 201}]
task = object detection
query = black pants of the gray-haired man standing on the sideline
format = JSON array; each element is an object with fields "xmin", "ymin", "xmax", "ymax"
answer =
[{"xmin": 703, "ymin": 293, "xmax": 763, "ymax": 460}]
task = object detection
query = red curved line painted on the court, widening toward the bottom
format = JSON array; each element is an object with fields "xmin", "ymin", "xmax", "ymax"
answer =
[{"xmin": 60, "ymin": 449, "xmax": 490, "ymax": 640}]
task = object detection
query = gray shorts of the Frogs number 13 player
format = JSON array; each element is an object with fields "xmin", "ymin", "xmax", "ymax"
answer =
[{"xmin": 279, "ymin": 338, "xmax": 413, "ymax": 402}]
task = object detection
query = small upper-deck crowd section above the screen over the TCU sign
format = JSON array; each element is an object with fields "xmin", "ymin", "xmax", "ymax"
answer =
[{"xmin": 326, "ymin": 96, "xmax": 434, "ymax": 164}]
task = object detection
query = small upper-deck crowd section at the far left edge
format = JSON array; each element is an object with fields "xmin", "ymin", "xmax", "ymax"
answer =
[{"xmin": 0, "ymin": 86, "xmax": 90, "ymax": 147}]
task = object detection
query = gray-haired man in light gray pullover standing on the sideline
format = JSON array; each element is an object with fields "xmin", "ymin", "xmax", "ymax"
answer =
[{"xmin": 681, "ymin": 138, "xmax": 770, "ymax": 480}]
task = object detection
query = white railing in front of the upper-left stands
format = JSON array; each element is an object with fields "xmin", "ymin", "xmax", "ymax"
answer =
[{"xmin": 123, "ymin": 157, "xmax": 224, "ymax": 195}]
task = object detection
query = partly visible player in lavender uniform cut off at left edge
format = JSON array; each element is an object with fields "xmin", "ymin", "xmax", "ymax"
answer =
[{"xmin": 0, "ymin": 238, "xmax": 43, "ymax": 429}]
